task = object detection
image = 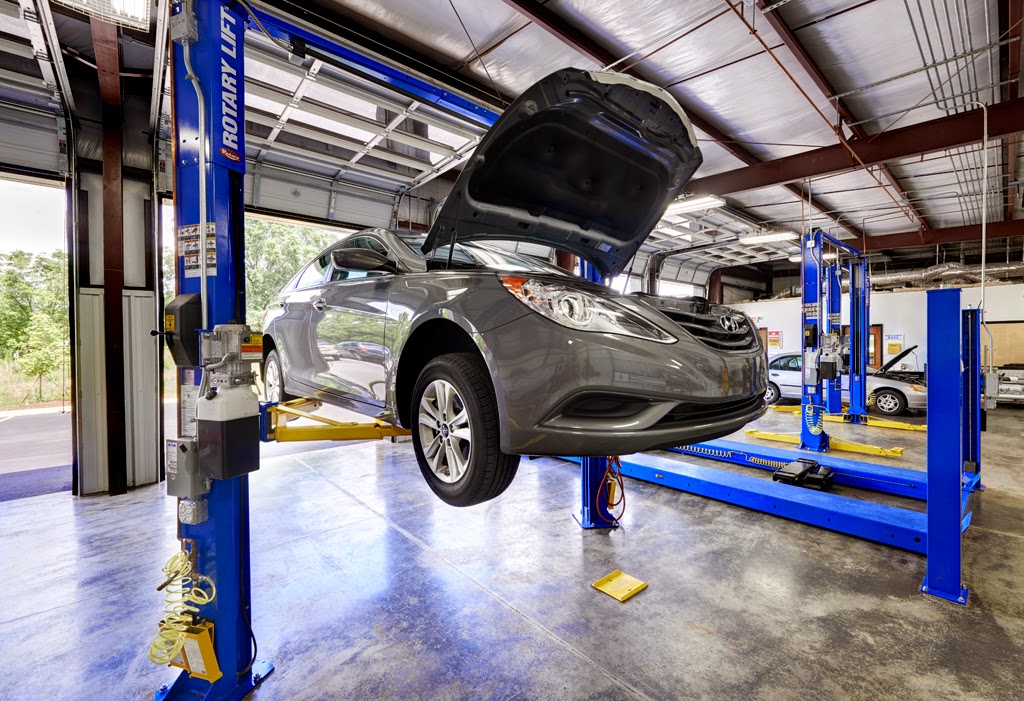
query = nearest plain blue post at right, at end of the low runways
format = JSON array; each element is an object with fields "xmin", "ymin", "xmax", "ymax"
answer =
[{"xmin": 921, "ymin": 290, "xmax": 968, "ymax": 604}]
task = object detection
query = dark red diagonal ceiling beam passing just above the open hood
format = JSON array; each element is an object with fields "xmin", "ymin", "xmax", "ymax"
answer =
[{"xmin": 503, "ymin": 0, "xmax": 862, "ymax": 237}]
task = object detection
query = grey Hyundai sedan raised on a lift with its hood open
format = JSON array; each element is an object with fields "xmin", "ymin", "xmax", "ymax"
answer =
[{"xmin": 264, "ymin": 69, "xmax": 767, "ymax": 506}]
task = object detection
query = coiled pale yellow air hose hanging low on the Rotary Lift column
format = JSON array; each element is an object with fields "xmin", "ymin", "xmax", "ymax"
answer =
[{"xmin": 150, "ymin": 551, "xmax": 217, "ymax": 665}]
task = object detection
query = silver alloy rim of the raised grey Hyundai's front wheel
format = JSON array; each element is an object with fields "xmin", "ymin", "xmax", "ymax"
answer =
[{"xmin": 418, "ymin": 380, "xmax": 473, "ymax": 484}]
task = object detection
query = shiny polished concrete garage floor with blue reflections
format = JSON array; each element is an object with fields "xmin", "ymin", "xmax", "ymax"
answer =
[{"xmin": 0, "ymin": 408, "xmax": 1024, "ymax": 700}]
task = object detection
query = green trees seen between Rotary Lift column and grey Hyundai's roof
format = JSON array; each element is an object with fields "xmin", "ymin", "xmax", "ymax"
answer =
[{"xmin": 246, "ymin": 219, "xmax": 339, "ymax": 330}]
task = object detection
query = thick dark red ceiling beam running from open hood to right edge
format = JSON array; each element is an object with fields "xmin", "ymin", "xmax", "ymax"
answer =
[{"xmin": 689, "ymin": 98, "xmax": 1024, "ymax": 195}]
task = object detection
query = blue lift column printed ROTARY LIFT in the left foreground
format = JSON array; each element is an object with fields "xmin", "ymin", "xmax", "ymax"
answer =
[{"xmin": 156, "ymin": 0, "xmax": 273, "ymax": 701}]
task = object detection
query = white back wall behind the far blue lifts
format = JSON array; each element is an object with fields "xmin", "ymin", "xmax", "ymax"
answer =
[{"xmin": 733, "ymin": 284, "xmax": 1024, "ymax": 369}]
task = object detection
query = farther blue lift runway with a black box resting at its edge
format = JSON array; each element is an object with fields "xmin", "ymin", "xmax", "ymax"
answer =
[{"xmin": 670, "ymin": 438, "xmax": 928, "ymax": 500}]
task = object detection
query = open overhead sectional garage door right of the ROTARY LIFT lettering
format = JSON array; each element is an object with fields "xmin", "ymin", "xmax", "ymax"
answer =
[{"xmin": 154, "ymin": 12, "xmax": 486, "ymax": 226}]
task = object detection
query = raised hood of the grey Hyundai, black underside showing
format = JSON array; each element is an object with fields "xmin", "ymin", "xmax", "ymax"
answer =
[{"xmin": 423, "ymin": 69, "xmax": 703, "ymax": 276}]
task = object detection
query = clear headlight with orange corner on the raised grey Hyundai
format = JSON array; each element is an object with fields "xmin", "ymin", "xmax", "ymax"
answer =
[{"xmin": 501, "ymin": 275, "xmax": 676, "ymax": 343}]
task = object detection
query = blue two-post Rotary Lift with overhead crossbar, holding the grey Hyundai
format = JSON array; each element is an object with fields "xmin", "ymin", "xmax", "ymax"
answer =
[{"xmin": 156, "ymin": 0, "xmax": 614, "ymax": 701}]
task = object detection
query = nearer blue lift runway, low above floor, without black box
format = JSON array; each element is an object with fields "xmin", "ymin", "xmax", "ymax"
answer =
[{"xmin": 598, "ymin": 453, "xmax": 927, "ymax": 553}]
